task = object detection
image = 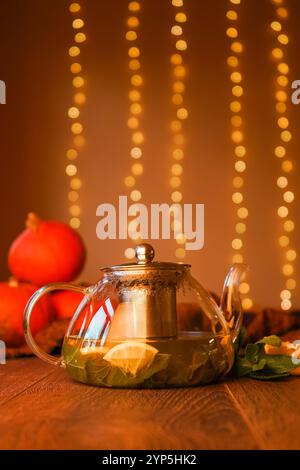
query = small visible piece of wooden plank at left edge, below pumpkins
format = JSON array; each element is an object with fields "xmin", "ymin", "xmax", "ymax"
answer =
[{"xmin": 0, "ymin": 357, "xmax": 54, "ymax": 404}]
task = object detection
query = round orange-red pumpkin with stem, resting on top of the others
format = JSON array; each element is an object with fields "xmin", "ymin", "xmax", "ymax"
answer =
[{"xmin": 8, "ymin": 213, "xmax": 86, "ymax": 286}]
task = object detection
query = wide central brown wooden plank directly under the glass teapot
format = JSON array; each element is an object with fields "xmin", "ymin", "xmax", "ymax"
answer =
[{"xmin": 0, "ymin": 362, "xmax": 258, "ymax": 449}]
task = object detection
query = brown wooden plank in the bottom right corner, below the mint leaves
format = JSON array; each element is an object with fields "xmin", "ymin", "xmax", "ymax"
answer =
[{"xmin": 226, "ymin": 377, "xmax": 300, "ymax": 449}]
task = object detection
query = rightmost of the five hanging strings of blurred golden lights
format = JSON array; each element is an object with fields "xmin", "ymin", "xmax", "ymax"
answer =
[{"xmin": 270, "ymin": 0, "xmax": 297, "ymax": 311}]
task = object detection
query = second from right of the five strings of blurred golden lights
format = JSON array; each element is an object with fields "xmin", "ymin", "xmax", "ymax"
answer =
[{"xmin": 226, "ymin": 0, "xmax": 253, "ymax": 310}]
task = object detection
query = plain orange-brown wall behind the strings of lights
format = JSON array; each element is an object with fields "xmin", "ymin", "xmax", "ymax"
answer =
[{"xmin": 0, "ymin": 0, "xmax": 300, "ymax": 307}]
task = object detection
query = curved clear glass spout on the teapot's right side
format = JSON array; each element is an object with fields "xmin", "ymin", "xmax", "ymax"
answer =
[{"xmin": 220, "ymin": 263, "xmax": 248, "ymax": 342}]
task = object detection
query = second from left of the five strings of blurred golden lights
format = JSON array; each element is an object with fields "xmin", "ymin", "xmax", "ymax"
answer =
[{"xmin": 124, "ymin": 1, "xmax": 144, "ymax": 259}]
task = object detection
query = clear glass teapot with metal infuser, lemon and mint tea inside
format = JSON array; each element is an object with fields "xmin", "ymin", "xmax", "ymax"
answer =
[{"xmin": 24, "ymin": 244, "xmax": 246, "ymax": 388}]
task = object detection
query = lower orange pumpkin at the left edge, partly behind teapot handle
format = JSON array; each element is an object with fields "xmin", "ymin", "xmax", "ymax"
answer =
[{"xmin": 0, "ymin": 279, "xmax": 53, "ymax": 348}]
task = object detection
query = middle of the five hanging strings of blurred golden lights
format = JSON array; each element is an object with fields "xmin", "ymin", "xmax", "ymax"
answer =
[{"xmin": 169, "ymin": 0, "xmax": 189, "ymax": 259}]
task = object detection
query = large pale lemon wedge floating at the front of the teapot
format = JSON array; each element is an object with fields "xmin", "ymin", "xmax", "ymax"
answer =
[{"xmin": 103, "ymin": 341, "xmax": 158, "ymax": 375}]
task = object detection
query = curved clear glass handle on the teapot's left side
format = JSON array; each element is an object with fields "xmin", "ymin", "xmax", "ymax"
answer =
[{"xmin": 23, "ymin": 282, "xmax": 87, "ymax": 366}]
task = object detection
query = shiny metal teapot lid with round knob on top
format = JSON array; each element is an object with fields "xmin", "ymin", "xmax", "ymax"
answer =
[{"xmin": 102, "ymin": 243, "xmax": 191, "ymax": 272}]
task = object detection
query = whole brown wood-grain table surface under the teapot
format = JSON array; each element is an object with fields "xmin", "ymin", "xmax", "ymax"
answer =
[{"xmin": 0, "ymin": 358, "xmax": 300, "ymax": 450}]
